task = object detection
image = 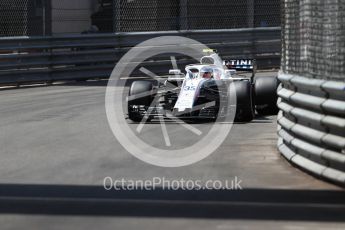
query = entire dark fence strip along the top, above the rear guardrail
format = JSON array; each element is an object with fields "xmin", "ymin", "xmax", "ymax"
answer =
[{"xmin": 0, "ymin": 0, "xmax": 281, "ymax": 36}]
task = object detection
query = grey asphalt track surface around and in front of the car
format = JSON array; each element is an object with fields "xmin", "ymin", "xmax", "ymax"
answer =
[{"xmin": 0, "ymin": 74, "xmax": 345, "ymax": 230}]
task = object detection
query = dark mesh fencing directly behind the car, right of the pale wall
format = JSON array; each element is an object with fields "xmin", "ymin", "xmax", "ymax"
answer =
[{"xmin": 113, "ymin": 0, "xmax": 281, "ymax": 32}]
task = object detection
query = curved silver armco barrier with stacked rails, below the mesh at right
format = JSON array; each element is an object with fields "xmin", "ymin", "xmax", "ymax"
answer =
[{"xmin": 278, "ymin": 72, "xmax": 345, "ymax": 184}]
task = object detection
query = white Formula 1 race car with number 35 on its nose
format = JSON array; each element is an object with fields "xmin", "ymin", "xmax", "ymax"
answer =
[{"xmin": 128, "ymin": 51, "xmax": 278, "ymax": 122}]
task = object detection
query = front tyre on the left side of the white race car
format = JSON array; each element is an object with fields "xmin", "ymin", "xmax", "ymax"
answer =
[{"xmin": 128, "ymin": 81, "xmax": 154, "ymax": 122}]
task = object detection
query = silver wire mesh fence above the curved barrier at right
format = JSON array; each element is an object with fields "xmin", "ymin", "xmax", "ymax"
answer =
[{"xmin": 282, "ymin": 0, "xmax": 345, "ymax": 80}]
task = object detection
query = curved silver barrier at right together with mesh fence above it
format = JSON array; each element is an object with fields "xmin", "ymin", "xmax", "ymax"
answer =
[{"xmin": 278, "ymin": 0, "xmax": 345, "ymax": 185}]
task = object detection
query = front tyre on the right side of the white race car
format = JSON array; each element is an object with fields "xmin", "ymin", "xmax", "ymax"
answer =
[{"xmin": 234, "ymin": 80, "xmax": 255, "ymax": 122}]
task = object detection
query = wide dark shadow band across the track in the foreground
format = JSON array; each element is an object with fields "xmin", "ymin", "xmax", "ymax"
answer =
[{"xmin": 0, "ymin": 184, "xmax": 345, "ymax": 222}]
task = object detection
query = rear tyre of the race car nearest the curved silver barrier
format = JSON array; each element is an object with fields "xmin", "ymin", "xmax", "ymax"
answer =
[{"xmin": 254, "ymin": 76, "xmax": 279, "ymax": 115}]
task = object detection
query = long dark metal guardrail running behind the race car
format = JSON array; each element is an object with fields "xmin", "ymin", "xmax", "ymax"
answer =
[{"xmin": 0, "ymin": 27, "xmax": 281, "ymax": 84}]
